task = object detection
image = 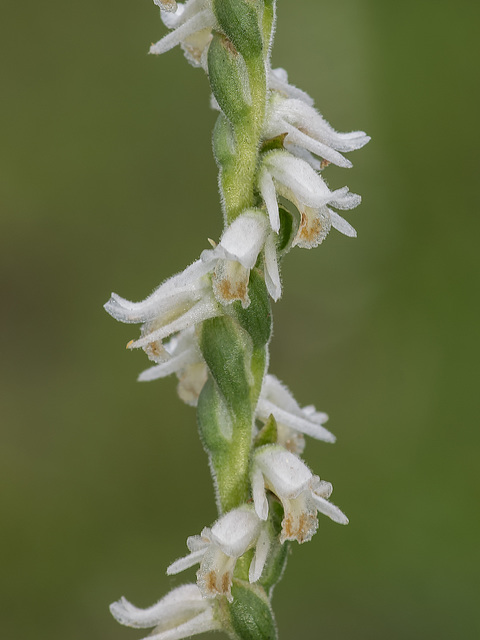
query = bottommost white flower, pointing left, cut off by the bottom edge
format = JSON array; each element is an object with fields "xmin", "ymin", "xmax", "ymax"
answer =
[{"xmin": 110, "ymin": 584, "xmax": 222, "ymax": 640}]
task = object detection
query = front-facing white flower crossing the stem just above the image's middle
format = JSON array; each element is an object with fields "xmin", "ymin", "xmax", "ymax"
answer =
[{"xmin": 201, "ymin": 209, "xmax": 281, "ymax": 308}]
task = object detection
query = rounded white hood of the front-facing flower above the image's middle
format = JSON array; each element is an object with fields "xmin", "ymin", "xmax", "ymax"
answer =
[{"xmin": 220, "ymin": 212, "xmax": 267, "ymax": 269}]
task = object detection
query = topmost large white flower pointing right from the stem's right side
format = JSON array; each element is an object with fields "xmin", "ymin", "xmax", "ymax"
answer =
[{"xmin": 263, "ymin": 94, "xmax": 370, "ymax": 168}]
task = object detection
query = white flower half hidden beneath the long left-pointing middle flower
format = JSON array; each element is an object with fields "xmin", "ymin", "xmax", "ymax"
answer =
[{"xmin": 138, "ymin": 327, "xmax": 207, "ymax": 407}]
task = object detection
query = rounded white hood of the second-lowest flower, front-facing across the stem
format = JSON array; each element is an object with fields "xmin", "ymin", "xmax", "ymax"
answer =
[{"xmin": 212, "ymin": 507, "xmax": 261, "ymax": 558}]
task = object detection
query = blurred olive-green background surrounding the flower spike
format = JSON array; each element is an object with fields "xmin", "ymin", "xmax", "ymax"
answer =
[{"xmin": 0, "ymin": 0, "xmax": 480, "ymax": 640}]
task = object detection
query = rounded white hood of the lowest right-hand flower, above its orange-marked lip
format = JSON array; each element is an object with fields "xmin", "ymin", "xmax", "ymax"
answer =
[{"xmin": 255, "ymin": 445, "xmax": 312, "ymax": 498}]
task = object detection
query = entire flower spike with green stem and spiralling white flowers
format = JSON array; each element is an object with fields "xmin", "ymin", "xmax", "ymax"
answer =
[{"xmin": 105, "ymin": 0, "xmax": 369, "ymax": 640}]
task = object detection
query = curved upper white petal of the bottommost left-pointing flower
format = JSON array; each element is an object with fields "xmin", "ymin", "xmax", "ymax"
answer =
[{"xmin": 110, "ymin": 584, "xmax": 206, "ymax": 629}]
